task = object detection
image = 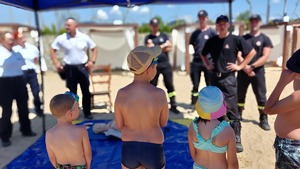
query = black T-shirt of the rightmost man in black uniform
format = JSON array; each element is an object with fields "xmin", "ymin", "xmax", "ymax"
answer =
[{"xmin": 243, "ymin": 33, "xmax": 273, "ymax": 67}]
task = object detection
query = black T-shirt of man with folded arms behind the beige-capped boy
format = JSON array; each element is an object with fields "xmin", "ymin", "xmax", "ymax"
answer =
[{"xmin": 144, "ymin": 32, "xmax": 170, "ymax": 67}]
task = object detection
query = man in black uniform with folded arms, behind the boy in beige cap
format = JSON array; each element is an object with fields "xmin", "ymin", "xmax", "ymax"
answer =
[{"xmin": 144, "ymin": 18, "xmax": 180, "ymax": 114}]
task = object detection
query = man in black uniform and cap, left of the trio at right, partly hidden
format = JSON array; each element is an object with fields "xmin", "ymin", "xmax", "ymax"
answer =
[{"xmin": 190, "ymin": 10, "xmax": 217, "ymax": 105}]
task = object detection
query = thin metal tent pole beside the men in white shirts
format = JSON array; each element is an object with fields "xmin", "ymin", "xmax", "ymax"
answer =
[{"xmin": 34, "ymin": 10, "xmax": 46, "ymax": 133}]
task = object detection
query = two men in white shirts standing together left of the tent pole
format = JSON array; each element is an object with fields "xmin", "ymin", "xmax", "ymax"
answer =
[{"xmin": 0, "ymin": 32, "xmax": 43, "ymax": 147}]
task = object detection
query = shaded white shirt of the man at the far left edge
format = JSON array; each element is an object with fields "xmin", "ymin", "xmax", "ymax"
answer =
[{"xmin": 0, "ymin": 45, "xmax": 25, "ymax": 77}]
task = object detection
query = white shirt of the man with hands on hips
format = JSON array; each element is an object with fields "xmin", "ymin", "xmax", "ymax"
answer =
[{"xmin": 51, "ymin": 30, "xmax": 96, "ymax": 65}]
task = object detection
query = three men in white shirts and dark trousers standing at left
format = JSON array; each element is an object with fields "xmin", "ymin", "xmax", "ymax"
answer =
[{"xmin": 0, "ymin": 18, "xmax": 97, "ymax": 147}]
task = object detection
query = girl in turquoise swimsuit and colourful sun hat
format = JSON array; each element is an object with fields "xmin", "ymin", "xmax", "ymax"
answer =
[{"xmin": 188, "ymin": 86, "xmax": 239, "ymax": 169}]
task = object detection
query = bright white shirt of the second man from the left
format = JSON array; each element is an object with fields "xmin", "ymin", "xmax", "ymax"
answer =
[{"xmin": 13, "ymin": 42, "xmax": 39, "ymax": 70}]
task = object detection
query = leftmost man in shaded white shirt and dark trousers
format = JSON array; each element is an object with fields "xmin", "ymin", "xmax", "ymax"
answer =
[{"xmin": 0, "ymin": 32, "xmax": 36, "ymax": 147}]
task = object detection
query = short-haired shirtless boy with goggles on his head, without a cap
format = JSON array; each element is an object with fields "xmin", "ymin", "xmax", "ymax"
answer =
[{"xmin": 46, "ymin": 92, "xmax": 92, "ymax": 169}]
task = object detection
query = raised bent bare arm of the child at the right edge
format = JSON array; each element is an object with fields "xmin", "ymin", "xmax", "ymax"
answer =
[{"xmin": 265, "ymin": 70, "xmax": 300, "ymax": 114}]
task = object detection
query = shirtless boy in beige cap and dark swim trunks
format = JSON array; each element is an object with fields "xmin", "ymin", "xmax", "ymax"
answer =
[{"xmin": 115, "ymin": 46, "xmax": 169, "ymax": 169}]
